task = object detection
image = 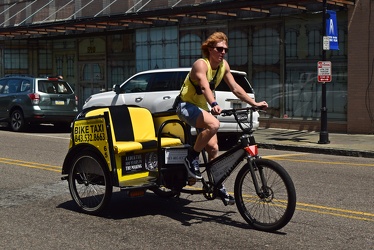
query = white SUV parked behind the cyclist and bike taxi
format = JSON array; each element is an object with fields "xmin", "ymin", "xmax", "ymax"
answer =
[{"xmin": 83, "ymin": 68, "xmax": 259, "ymax": 135}]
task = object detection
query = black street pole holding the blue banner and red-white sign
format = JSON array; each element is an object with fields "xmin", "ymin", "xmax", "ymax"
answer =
[{"xmin": 318, "ymin": 0, "xmax": 330, "ymax": 144}]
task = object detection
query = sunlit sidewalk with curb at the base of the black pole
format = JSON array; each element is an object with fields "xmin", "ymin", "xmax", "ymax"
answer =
[{"xmin": 254, "ymin": 128, "xmax": 374, "ymax": 158}]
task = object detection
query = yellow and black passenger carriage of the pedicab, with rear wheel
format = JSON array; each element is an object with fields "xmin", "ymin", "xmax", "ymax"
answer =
[{"xmin": 62, "ymin": 105, "xmax": 188, "ymax": 214}]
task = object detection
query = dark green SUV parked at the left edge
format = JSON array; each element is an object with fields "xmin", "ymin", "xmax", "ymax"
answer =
[{"xmin": 0, "ymin": 76, "xmax": 78, "ymax": 131}]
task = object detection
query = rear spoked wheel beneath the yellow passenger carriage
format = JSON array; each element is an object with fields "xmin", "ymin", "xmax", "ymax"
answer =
[{"xmin": 68, "ymin": 150, "xmax": 113, "ymax": 214}]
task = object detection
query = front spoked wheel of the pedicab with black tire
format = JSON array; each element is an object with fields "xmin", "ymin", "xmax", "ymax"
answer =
[{"xmin": 234, "ymin": 159, "xmax": 296, "ymax": 231}]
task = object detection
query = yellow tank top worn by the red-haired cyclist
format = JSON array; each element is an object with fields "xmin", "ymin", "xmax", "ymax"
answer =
[{"xmin": 181, "ymin": 58, "xmax": 225, "ymax": 111}]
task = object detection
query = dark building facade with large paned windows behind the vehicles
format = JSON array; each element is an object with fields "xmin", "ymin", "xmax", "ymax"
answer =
[{"xmin": 0, "ymin": 0, "xmax": 374, "ymax": 134}]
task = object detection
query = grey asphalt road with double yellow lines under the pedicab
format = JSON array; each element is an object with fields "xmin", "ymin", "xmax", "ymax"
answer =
[{"xmin": 0, "ymin": 127, "xmax": 374, "ymax": 249}]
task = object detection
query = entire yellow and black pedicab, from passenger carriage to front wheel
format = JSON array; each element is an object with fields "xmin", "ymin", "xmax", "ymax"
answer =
[{"xmin": 62, "ymin": 105, "xmax": 296, "ymax": 231}]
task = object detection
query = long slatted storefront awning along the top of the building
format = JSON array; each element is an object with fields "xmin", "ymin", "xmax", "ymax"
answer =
[{"xmin": 0, "ymin": 0, "xmax": 355, "ymax": 39}]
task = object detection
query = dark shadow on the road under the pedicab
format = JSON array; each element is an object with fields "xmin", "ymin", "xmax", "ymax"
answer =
[{"xmin": 58, "ymin": 192, "xmax": 260, "ymax": 229}]
